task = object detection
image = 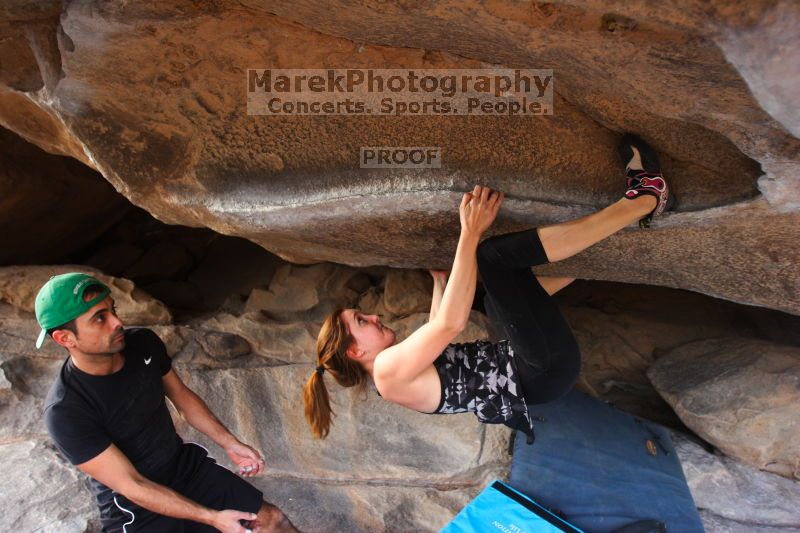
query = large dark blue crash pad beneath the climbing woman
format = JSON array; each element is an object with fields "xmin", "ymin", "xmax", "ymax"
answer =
[{"xmin": 509, "ymin": 390, "xmax": 704, "ymax": 533}]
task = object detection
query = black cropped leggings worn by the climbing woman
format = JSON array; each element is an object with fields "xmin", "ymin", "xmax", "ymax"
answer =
[{"xmin": 478, "ymin": 229, "xmax": 581, "ymax": 404}]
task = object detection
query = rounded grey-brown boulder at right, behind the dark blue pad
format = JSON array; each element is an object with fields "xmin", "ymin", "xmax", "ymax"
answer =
[{"xmin": 647, "ymin": 338, "xmax": 800, "ymax": 479}]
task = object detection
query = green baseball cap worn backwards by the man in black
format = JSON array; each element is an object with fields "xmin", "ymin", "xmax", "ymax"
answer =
[{"xmin": 34, "ymin": 272, "xmax": 111, "ymax": 350}]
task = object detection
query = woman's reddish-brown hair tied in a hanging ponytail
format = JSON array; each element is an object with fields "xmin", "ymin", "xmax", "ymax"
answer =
[{"xmin": 303, "ymin": 309, "xmax": 368, "ymax": 439}]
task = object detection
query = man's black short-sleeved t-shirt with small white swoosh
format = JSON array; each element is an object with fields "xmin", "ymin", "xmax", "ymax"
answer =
[{"xmin": 44, "ymin": 328, "xmax": 183, "ymax": 516}]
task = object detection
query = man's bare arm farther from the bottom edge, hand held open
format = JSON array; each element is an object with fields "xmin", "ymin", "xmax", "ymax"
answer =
[{"xmin": 161, "ymin": 369, "xmax": 264, "ymax": 477}]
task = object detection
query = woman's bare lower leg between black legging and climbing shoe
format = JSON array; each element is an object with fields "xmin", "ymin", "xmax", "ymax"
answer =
[{"xmin": 537, "ymin": 195, "xmax": 656, "ymax": 262}]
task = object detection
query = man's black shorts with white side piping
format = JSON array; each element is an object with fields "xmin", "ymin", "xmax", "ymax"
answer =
[{"xmin": 103, "ymin": 443, "xmax": 263, "ymax": 533}]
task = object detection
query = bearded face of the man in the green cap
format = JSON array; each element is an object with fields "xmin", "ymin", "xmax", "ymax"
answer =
[{"xmin": 68, "ymin": 296, "xmax": 125, "ymax": 355}]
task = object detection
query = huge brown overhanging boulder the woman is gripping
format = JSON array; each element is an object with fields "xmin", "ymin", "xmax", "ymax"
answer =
[{"xmin": 0, "ymin": 0, "xmax": 800, "ymax": 313}]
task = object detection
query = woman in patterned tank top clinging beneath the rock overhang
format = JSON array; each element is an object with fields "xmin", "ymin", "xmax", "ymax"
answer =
[{"xmin": 304, "ymin": 134, "xmax": 674, "ymax": 442}]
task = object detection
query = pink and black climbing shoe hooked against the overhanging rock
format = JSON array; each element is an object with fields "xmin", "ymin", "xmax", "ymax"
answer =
[{"xmin": 619, "ymin": 133, "xmax": 675, "ymax": 228}]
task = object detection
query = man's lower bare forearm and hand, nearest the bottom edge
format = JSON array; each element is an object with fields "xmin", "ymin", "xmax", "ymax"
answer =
[{"xmin": 78, "ymin": 444, "xmax": 256, "ymax": 533}]
